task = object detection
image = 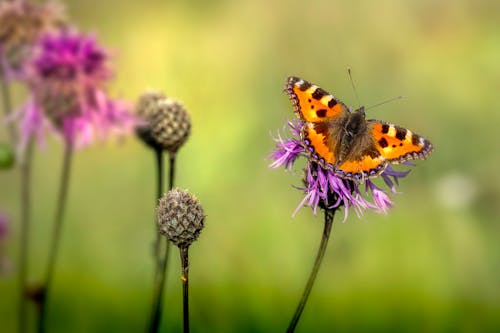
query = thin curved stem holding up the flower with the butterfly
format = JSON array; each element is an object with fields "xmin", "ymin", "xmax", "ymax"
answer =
[{"xmin": 286, "ymin": 209, "xmax": 335, "ymax": 333}]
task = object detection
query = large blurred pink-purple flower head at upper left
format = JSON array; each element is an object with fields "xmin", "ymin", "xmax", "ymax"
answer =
[{"xmin": 18, "ymin": 31, "xmax": 136, "ymax": 147}]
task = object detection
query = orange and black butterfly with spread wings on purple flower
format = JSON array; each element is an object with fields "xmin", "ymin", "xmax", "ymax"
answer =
[{"xmin": 285, "ymin": 76, "xmax": 433, "ymax": 183}]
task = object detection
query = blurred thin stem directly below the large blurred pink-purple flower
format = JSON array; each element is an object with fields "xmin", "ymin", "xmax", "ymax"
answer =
[{"xmin": 38, "ymin": 142, "xmax": 73, "ymax": 333}]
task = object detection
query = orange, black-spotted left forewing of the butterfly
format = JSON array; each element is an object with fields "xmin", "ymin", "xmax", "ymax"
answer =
[{"xmin": 285, "ymin": 76, "xmax": 349, "ymax": 122}]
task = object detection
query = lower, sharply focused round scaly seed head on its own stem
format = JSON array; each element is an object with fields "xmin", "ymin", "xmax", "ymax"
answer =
[{"xmin": 156, "ymin": 188, "xmax": 205, "ymax": 248}]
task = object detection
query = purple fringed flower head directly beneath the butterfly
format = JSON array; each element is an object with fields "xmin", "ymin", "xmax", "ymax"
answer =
[{"xmin": 270, "ymin": 120, "xmax": 412, "ymax": 221}]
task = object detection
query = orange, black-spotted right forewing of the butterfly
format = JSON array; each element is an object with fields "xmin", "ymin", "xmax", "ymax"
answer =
[{"xmin": 368, "ymin": 120, "xmax": 432, "ymax": 163}]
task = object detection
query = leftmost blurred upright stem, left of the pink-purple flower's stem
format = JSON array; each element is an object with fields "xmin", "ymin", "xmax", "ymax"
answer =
[{"xmin": 18, "ymin": 139, "xmax": 34, "ymax": 333}]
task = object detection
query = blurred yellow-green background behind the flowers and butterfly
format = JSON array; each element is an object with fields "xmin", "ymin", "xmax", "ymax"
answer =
[{"xmin": 0, "ymin": 0, "xmax": 500, "ymax": 332}]
